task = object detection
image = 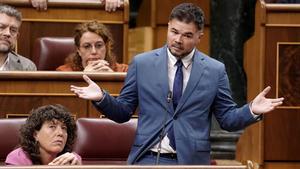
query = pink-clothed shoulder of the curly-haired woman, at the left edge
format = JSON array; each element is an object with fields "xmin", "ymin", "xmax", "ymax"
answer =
[{"xmin": 5, "ymin": 148, "xmax": 32, "ymax": 165}]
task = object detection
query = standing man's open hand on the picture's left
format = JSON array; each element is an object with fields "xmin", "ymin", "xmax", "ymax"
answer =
[{"xmin": 71, "ymin": 75, "xmax": 103, "ymax": 101}]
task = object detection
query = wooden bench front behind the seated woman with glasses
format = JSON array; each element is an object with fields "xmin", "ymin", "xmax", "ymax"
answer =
[{"xmin": 0, "ymin": 0, "xmax": 129, "ymax": 63}]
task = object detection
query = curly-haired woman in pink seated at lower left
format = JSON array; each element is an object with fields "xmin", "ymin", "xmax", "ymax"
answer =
[{"xmin": 5, "ymin": 105, "xmax": 81, "ymax": 165}]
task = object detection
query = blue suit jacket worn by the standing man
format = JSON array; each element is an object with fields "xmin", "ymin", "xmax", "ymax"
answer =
[{"xmin": 93, "ymin": 46, "xmax": 256, "ymax": 165}]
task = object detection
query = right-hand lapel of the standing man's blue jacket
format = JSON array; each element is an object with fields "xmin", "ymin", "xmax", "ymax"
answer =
[{"xmin": 175, "ymin": 50, "xmax": 205, "ymax": 114}]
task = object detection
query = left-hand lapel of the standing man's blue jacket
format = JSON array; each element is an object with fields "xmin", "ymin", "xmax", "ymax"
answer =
[{"xmin": 153, "ymin": 46, "xmax": 174, "ymax": 114}]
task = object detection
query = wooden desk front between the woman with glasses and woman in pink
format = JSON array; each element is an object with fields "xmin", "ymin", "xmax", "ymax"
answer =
[{"xmin": 0, "ymin": 71, "xmax": 126, "ymax": 118}]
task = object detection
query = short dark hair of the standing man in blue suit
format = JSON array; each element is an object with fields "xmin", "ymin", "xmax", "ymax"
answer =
[{"xmin": 169, "ymin": 3, "xmax": 204, "ymax": 30}]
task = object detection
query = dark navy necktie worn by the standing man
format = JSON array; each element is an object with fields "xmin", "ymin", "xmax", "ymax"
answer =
[{"xmin": 168, "ymin": 59, "xmax": 183, "ymax": 150}]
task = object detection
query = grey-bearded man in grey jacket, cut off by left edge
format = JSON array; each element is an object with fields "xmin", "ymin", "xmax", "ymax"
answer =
[{"xmin": 0, "ymin": 4, "xmax": 36, "ymax": 71}]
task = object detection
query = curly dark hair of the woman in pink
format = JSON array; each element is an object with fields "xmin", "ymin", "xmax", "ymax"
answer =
[{"xmin": 20, "ymin": 104, "xmax": 77, "ymax": 164}]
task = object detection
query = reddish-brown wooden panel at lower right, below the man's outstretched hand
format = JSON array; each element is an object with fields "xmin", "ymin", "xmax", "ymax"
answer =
[{"xmin": 264, "ymin": 109, "xmax": 300, "ymax": 161}]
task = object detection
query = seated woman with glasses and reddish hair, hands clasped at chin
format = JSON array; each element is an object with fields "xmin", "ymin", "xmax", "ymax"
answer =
[{"xmin": 56, "ymin": 21, "xmax": 128, "ymax": 72}]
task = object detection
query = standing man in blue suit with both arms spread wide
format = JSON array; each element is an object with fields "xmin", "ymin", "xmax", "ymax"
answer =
[{"xmin": 71, "ymin": 3, "xmax": 283, "ymax": 165}]
